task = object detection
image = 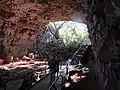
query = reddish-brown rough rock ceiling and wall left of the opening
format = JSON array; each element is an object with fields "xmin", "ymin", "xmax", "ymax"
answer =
[{"xmin": 0, "ymin": 0, "xmax": 79, "ymax": 56}]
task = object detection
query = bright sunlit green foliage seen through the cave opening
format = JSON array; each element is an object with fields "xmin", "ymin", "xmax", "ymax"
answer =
[{"xmin": 49, "ymin": 21, "xmax": 90, "ymax": 47}]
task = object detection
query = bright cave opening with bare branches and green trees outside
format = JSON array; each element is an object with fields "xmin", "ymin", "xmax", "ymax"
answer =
[{"xmin": 36, "ymin": 21, "xmax": 91, "ymax": 60}]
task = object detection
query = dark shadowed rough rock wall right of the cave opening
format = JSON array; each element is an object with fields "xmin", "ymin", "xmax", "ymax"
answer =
[{"xmin": 81, "ymin": 0, "xmax": 120, "ymax": 90}]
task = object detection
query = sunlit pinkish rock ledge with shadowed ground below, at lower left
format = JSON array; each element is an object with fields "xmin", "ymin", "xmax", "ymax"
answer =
[{"xmin": 0, "ymin": 61, "xmax": 49, "ymax": 90}]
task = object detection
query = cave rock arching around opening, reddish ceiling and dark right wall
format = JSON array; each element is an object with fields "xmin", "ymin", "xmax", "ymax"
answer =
[{"xmin": 0, "ymin": 0, "xmax": 120, "ymax": 90}]
